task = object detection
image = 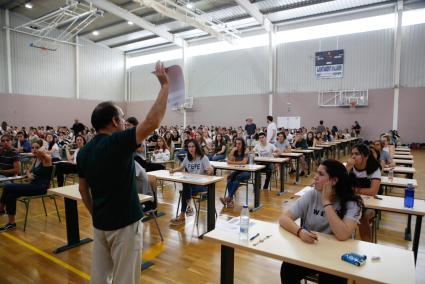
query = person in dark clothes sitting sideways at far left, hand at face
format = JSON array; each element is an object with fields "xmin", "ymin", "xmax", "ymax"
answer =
[{"xmin": 0, "ymin": 140, "xmax": 52, "ymax": 232}]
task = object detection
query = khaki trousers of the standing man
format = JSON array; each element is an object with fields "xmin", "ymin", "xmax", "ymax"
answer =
[{"xmin": 90, "ymin": 221, "xmax": 143, "ymax": 284}]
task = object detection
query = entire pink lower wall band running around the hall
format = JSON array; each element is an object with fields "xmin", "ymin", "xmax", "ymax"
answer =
[{"xmin": 0, "ymin": 88, "xmax": 425, "ymax": 143}]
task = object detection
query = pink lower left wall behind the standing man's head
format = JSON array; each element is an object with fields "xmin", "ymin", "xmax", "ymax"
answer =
[{"xmin": 0, "ymin": 93, "xmax": 125, "ymax": 127}]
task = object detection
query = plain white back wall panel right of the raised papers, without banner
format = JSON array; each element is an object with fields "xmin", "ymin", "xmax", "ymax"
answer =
[{"xmin": 188, "ymin": 47, "xmax": 268, "ymax": 98}]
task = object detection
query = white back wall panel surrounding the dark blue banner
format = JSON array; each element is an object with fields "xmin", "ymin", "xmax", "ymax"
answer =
[{"xmin": 277, "ymin": 29, "xmax": 393, "ymax": 92}]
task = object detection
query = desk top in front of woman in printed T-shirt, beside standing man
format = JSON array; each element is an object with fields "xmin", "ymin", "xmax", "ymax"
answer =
[{"xmin": 147, "ymin": 170, "xmax": 224, "ymax": 185}]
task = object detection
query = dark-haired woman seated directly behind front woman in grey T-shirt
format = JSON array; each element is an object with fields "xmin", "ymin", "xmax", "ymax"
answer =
[{"xmin": 346, "ymin": 144, "xmax": 381, "ymax": 242}]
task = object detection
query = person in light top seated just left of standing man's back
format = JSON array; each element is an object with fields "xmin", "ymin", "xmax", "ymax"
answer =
[{"xmin": 55, "ymin": 134, "xmax": 86, "ymax": 187}]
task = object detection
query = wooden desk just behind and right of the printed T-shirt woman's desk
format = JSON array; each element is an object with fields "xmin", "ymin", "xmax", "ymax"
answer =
[{"xmin": 210, "ymin": 161, "xmax": 266, "ymax": 211}]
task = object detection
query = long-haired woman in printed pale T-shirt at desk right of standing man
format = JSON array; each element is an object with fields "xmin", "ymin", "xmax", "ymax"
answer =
[{"xmin": 170, "ymin": 140, "xmax": 210, "ymax": 226}]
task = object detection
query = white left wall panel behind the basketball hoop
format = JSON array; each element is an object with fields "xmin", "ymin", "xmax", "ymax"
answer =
[{"xmin": 10, "ymin": 13, "xmax": 75, "ymax": 98}]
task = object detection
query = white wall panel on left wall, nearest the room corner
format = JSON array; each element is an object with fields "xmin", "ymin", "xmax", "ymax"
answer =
[{"xmin": 79, "ymin": 39, "xmax": 125, "ymax": 101}]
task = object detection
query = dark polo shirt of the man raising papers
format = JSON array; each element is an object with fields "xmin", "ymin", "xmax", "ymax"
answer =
[{"xmin": 77, "ymin": 128, "xmax": 143, "ymax": 231}]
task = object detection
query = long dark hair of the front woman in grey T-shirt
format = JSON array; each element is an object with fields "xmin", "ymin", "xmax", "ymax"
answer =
[{"xmin": 321, "ymin": 159, "xmax": 363, "ymax": 219}]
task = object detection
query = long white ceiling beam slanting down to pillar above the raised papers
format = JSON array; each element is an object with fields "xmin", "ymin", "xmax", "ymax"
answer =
[{"xmin": 86, "ymin": 0, "xmax": 184, "ymax": 46}]
